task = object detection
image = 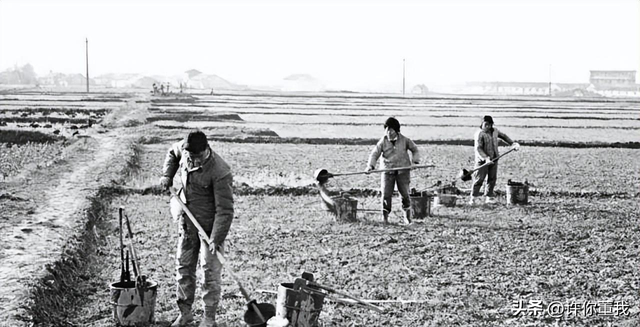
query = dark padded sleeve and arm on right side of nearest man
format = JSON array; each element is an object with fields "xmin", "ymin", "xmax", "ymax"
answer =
[{"xmin": 211, "ymin": 171, "xmax": 233, "ymax": 245}]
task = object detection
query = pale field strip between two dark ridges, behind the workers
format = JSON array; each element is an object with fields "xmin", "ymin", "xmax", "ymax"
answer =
[{"xmin": 136, "ymin": 142, "xmax": 640, "ymax": 195}]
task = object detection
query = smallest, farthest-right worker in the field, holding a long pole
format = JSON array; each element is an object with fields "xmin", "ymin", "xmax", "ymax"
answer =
[{"xmin": 469, "ymin": 116, "xmax": 520, "ymax": 205}]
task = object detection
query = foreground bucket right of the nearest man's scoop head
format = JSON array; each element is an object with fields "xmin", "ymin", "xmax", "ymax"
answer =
[{"xmin": 276, "ymin": 283, "xmax": 324, "ymax": 327}]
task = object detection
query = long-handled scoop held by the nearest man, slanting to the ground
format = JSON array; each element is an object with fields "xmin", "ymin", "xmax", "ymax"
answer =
[{"xmin": 169, "ymin": 187, "xmax": 276, "ymax": 323}]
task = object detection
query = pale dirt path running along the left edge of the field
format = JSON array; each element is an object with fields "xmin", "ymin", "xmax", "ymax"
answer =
[{"xmin": 0, "ymin": 131, "xmax": 118, "ymax": 326}]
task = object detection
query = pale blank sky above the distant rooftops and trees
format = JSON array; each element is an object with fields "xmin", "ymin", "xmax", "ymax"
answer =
[{"xmin": 0, "ymin": 0, "xmax": 640, "ymax": 89}]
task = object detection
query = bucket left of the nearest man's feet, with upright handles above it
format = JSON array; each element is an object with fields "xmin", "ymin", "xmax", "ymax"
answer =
[{"xmin": 109, "ymin": 280, "xmax": 158, "ymax": 326}]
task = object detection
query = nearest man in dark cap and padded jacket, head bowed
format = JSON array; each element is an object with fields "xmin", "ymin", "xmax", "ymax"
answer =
[{"xmin": 160, "ymin": 131, "xmax": 233, "ymax": 327}]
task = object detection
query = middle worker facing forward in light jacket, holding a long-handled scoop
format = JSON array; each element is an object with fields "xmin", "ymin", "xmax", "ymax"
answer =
[{"xmin": 367, "ymin": 117, "xmax": 420, "ymax": 224}]
